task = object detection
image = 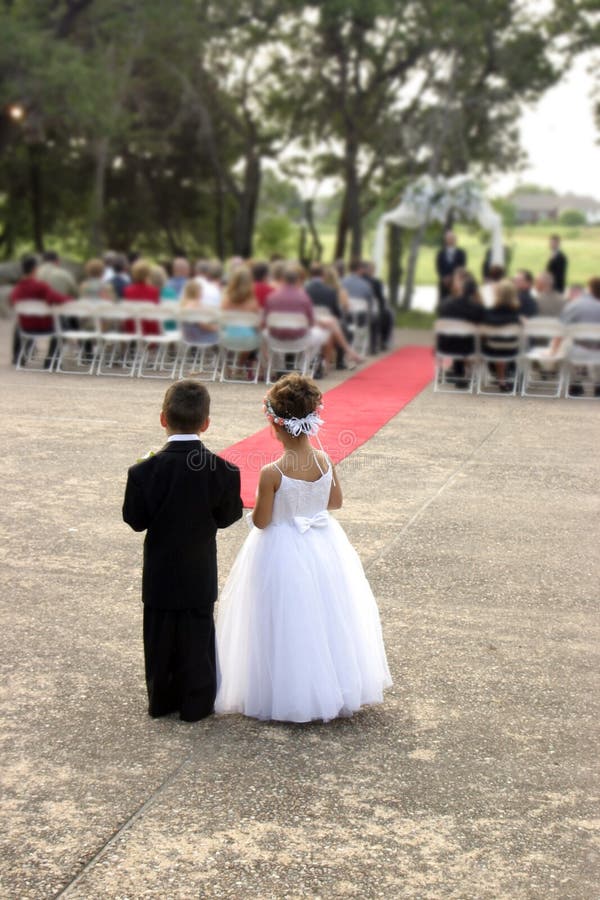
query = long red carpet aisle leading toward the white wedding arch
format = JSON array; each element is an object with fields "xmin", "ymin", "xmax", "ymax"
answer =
[{"xmin": 220, "ymin": 347, "xmax": 433, "ymax": 509}]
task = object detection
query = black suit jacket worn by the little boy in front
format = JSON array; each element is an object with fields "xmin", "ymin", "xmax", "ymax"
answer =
[{"xmin": 123, "ymin": 440, "xmax": 242, "ymax": 609}]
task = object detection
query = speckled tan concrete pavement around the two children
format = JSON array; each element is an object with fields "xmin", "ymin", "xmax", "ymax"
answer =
[{"xmin": 0, "ymin": 322, "xmax": 600, "ymax": 900}]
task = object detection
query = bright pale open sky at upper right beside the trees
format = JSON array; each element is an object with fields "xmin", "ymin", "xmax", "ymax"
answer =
[{"xmin": 491, "ymin": 56, "xmax": 600, "ymax": 200}]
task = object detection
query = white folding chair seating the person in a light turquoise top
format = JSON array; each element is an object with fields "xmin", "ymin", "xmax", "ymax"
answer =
[{"xmin": 219, "ymin": 310, "xmax": 262, "ymax": 384}]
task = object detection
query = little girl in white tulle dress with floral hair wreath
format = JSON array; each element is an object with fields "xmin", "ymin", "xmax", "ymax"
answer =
[{"xmin": 215, "ymin": 375, "xmax": 392, "ymax": 722}]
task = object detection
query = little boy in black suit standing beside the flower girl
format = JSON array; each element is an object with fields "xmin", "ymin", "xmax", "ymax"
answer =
[{"xmin": 123, "ymin": 380, "xmax": 242, "ymax": 722}]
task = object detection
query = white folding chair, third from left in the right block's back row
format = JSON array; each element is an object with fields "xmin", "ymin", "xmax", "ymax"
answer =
[{"xmin": 521, "ymin": 316, "xmax": 566, "ymax": 397}]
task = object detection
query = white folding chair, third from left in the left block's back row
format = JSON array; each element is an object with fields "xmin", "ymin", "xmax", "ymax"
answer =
[{"xmin": 96, "ymin": 302, "xmax": 142, "ymax": 378}]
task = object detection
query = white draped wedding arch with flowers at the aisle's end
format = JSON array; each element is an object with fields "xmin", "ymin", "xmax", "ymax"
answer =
[{"xmin": 373, "ymin": 175, "xmax": 504, "ymax": 273}]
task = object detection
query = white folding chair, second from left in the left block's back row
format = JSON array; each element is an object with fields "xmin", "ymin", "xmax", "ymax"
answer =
[{"xmin": 54, "ymin": 300, "xmax": 100, "ymax": 375}]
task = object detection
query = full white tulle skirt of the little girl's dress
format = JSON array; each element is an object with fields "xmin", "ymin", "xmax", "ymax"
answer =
[{"xmin": 215, "ymin": 518, "xmax": 392, "ymax": 722}]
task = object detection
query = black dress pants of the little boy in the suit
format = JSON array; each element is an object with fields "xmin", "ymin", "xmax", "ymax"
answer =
[{"xmin": 144, "ymin": 606, "xmax": 217, "ymax": 722}]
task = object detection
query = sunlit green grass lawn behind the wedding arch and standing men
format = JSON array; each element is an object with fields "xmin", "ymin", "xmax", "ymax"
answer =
[{"xmin": 320, "ymin": 224, "xmax": 600, "ymax": 284}]
